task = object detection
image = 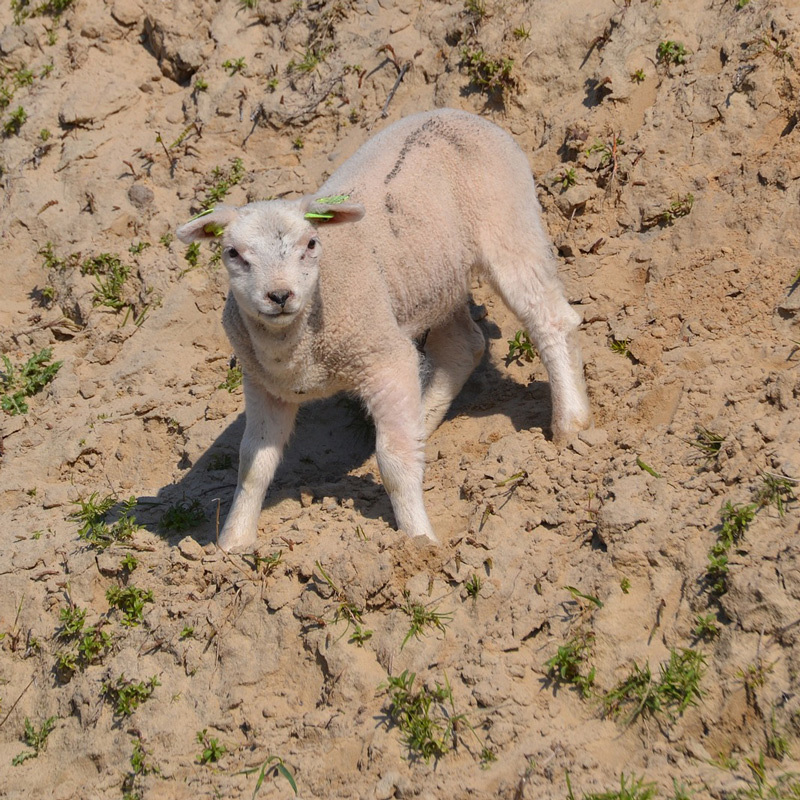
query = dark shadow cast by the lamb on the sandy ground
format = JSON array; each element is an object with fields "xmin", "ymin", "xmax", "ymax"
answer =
[{"xmin": 144, "ymin": 323, "xmax": 551, "ymax": 544}]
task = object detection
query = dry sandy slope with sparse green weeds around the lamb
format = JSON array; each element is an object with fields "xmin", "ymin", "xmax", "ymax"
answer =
[{"xmin": 0, "ymin": 0, "xmax": 800, "ymax": 800}]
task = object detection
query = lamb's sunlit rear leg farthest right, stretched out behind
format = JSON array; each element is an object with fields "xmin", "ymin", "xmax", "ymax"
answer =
[{"xmin": 490, "ymin": 255, "xmax": 590, "ymax": 441}]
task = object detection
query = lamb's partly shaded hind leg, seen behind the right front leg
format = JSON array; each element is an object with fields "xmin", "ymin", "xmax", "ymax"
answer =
[{"xmin": 423, "ymin": 305, "xmax": 486, "ymax": 437}]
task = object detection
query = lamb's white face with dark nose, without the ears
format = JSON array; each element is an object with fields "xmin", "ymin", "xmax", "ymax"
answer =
[{"xmin": 222, "ymin": 201, "xmax": 322, "ymax": 327}]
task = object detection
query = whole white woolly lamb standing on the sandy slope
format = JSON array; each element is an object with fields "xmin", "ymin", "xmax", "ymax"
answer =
[{"xmin": 177, "ymin": 109, "xmax": 590, "ymax": 552}]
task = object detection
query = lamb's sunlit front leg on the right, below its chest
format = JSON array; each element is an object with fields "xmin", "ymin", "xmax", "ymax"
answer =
[{"xmin": 361, "ymin": 342, "xmax": 437, "ymax": 542}]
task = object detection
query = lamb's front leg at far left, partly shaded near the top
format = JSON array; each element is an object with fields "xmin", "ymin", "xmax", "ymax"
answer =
[{"xmin": 219, "ymin": 376, "xmax": 297, "ymax": 552}]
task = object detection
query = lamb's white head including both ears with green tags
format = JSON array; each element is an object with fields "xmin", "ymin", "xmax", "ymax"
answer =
[{"xmin": 177, "ymin": 195, "xmax": 364, "ymax": 327}]
